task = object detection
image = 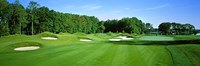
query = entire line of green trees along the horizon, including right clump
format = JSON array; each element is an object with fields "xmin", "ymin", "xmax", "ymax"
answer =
[{"xmin": 0, "ymin": 0, "xmax": 196, "ymax": 36}]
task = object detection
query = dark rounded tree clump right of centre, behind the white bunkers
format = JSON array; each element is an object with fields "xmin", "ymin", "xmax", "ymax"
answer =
[{"xmin": 104, "ymin": 17, "xmax": 144, "ymax": 34}]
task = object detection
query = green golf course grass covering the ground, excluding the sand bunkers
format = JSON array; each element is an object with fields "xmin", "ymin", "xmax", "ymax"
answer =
[{"xmin": 0, "ymin": 33, "xmax": 200, "ymax": 66}]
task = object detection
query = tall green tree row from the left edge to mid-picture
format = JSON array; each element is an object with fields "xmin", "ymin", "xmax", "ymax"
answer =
[{"xmin": 0, "ymin": 0, "xmax": 104, "ymax": 36}]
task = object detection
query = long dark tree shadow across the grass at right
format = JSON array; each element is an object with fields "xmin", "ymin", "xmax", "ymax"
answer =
[{"xmin": 109, "ymin": 40, "xmax": 200, "ymax": 45}]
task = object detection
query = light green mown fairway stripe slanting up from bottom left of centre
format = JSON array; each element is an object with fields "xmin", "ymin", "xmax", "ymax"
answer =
[{"xmin": 38, "ymin": 45, "xmax": 103, "ymax": 66}]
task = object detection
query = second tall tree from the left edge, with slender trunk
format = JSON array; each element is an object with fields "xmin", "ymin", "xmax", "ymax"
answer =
[{"xmin": 9, "ymin": 0, "xmax": 27, "ymax": 34}]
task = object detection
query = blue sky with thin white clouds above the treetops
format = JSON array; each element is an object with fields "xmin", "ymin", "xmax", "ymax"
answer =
[{"xmin": 8, "ymin": 0, "xmax": 200, "ymax": 29}]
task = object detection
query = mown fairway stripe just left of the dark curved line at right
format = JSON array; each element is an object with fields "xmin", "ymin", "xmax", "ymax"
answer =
[{"xmin": 137, "ymin": 46, "xmax": 172, "ymax": 66}]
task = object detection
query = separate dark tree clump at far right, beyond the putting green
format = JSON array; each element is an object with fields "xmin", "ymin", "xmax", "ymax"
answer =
[{"xmin": 158, "ymin": 22, "xmax": 197, "ymax": 35}]
